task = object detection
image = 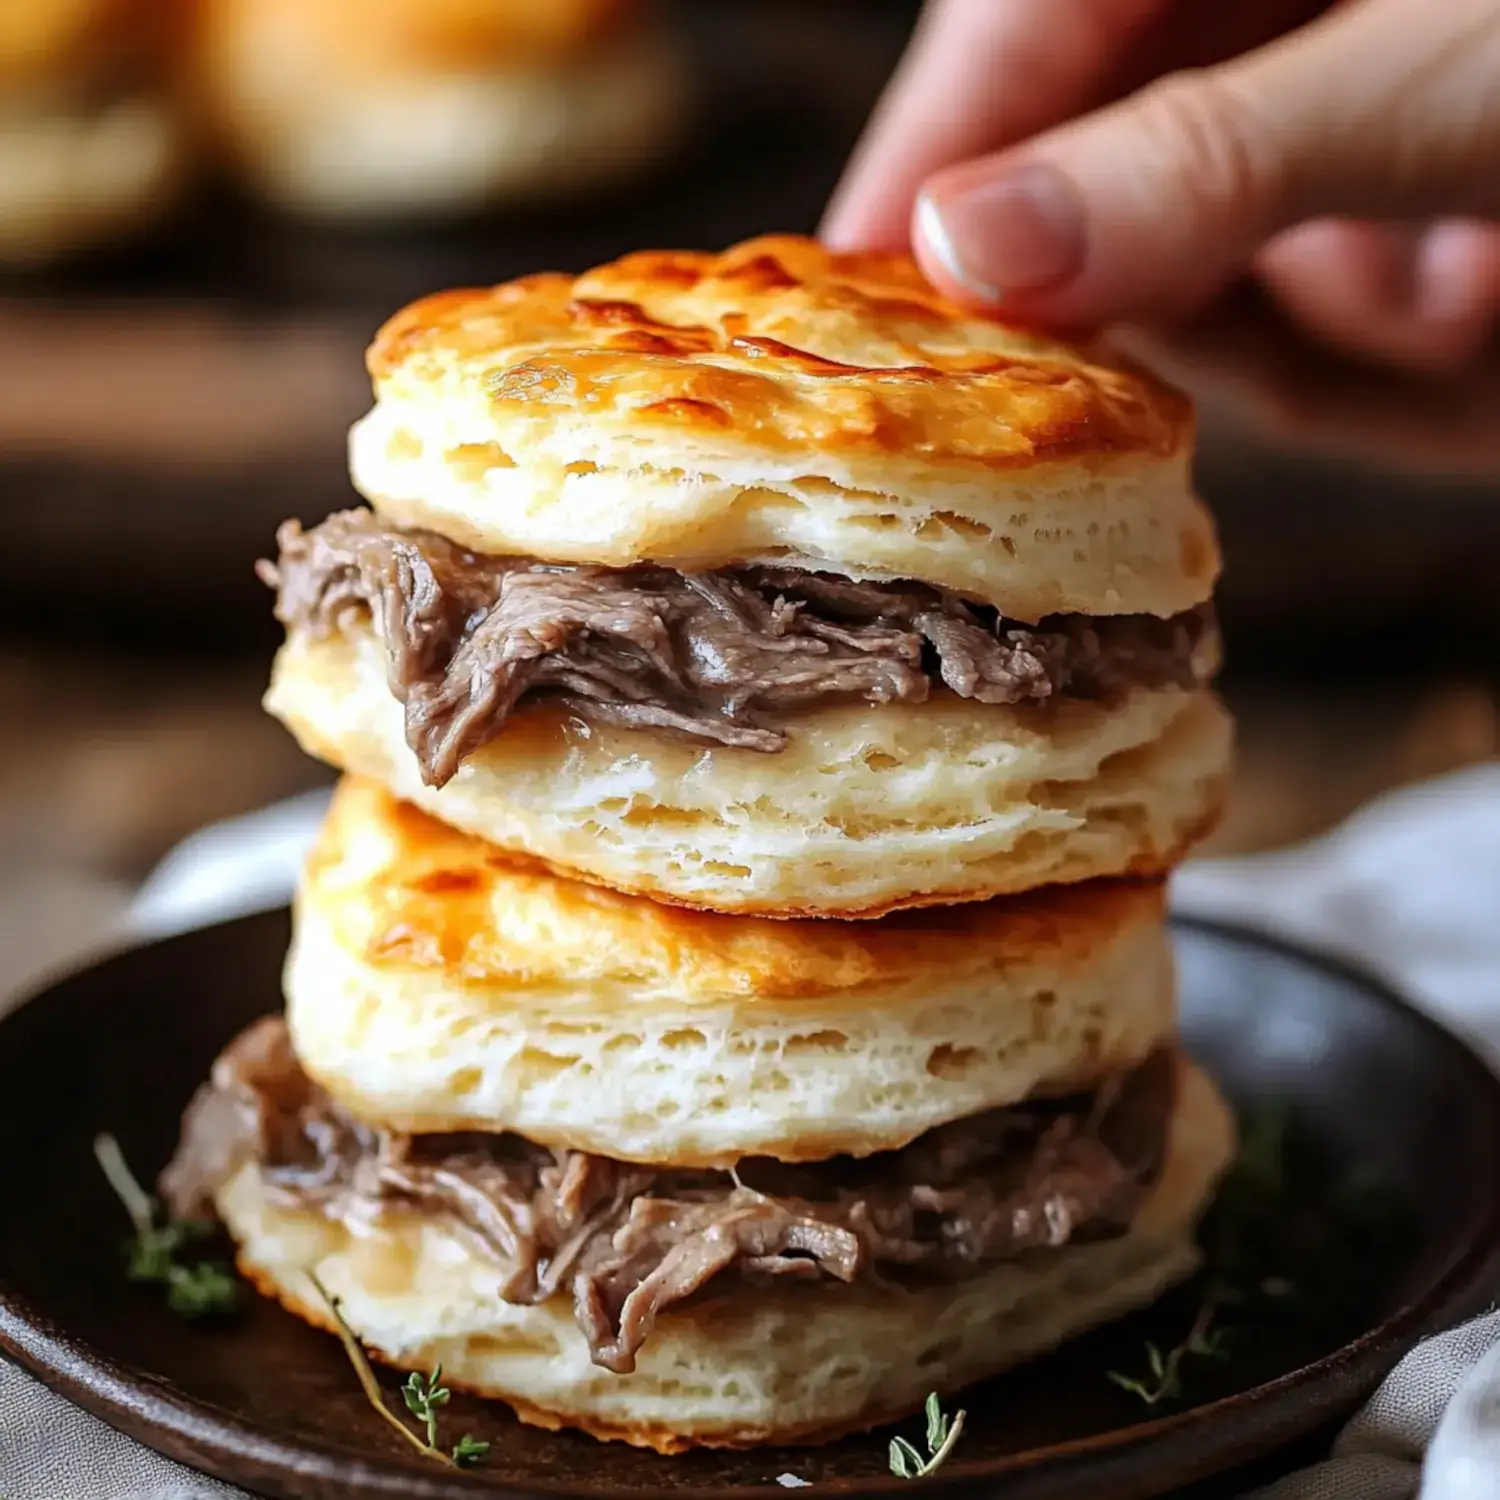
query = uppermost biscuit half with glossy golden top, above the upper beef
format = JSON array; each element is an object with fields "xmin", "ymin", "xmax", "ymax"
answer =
[{"xmin": 351, "ymin": 236, "xmax": 1218, "ymax": 620}]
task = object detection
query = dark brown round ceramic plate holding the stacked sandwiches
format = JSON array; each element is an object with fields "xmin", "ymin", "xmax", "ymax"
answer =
[{"xmin": 0, "ymin": 915, "xmax": 1500, "ymax": 1500}]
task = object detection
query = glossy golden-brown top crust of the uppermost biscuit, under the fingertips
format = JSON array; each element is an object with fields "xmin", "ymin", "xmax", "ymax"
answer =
[{"xmin": 369, "ymin": 236, "xmax": 1191, "ymax": 467}]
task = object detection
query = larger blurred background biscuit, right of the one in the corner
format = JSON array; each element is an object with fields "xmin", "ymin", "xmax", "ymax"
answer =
[{"xmin": 194, "ymin": 0, "xmax": 686, "ymax": 219}]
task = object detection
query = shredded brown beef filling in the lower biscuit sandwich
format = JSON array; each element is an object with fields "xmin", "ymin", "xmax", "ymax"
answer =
[{"xmin": 162, "ymin": 1017, "xmax": 1176, "ymax": 1373}]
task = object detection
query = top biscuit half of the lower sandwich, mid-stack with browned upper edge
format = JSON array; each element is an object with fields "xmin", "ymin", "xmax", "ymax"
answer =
[{"xmin": 287, "ymin": 780, "xmax": 1175, "ymax": 1166}]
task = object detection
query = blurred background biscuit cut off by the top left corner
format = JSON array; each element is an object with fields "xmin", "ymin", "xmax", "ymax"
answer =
[{"xmin": 0, "ymin": 0, "xmax": 188, "ymax": 267}]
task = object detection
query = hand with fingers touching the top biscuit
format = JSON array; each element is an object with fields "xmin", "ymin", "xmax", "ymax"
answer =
[{"xmin": 824, "ymin": 0, "xmax": 1500, "ymax": 368}]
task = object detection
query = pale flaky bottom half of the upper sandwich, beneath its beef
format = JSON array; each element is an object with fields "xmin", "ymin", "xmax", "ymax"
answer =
[{"xmin": 266, "ymin": 626, "xmax": 1232, "ymax": 917}]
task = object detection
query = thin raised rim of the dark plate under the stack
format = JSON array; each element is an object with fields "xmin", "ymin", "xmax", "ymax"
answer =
[{"xmin": 0, "ymin": 906, "xmax": 1500, "ymax": 1500}]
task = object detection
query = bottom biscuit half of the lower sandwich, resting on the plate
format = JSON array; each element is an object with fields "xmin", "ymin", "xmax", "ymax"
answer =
[{"xmin": 202, "ymin": 1065, "xmax": 1233, "ymax": 1452}]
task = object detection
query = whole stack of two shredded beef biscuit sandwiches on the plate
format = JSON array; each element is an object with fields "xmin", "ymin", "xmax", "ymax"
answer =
[{"xmin": 165, "ymin": 237, "xmax": 1233, "ymax": 1451}]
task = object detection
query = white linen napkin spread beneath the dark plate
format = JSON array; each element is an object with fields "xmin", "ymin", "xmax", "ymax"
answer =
[{"xmin": 0, "ymin": 762, "xmax": 1500, "ymax": 1500}]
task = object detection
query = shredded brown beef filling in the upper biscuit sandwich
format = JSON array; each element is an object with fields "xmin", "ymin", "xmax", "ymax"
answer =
[{"xmin": 260, "ymin": 510, "xmax": 1217, "ymax": 786}]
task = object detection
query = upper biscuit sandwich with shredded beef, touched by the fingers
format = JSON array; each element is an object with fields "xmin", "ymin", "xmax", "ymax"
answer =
[{"xmin": 264, "ymin": 236, "xmax": 1230, "ymax": 917}]
